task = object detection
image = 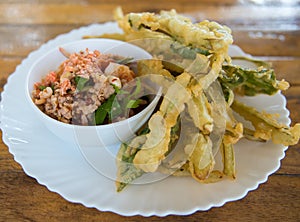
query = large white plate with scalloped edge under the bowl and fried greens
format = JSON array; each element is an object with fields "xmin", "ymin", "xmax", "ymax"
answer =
[{"xmin": 0, "ymin": 23, "xmax": 290, "ymax": 216}]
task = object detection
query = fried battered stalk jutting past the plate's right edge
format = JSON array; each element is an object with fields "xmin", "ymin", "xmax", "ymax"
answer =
[{"xmin": 231, "ymin": 100, "xmax": 300, "ymax": 146}]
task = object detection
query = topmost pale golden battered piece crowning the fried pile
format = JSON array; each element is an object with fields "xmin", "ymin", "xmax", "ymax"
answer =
[{"xmin": 115, "ymin": 8, "xmax": 232, "ymax": 50}]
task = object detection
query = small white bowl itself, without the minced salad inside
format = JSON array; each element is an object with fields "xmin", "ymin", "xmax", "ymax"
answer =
[{"xmin": 25, "ymin": 39, "xmax": 160, "ymax": 147}]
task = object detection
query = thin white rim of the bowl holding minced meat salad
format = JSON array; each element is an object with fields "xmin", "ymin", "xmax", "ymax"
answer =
[{"xmin": 25, "ymin": 38, "xmax": 162, "ymax": 129}]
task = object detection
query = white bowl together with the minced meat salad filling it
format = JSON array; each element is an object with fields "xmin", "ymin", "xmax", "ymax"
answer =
[{"xmin": 25, "ymin": 39, "xmax": 159, "ymax": 146}]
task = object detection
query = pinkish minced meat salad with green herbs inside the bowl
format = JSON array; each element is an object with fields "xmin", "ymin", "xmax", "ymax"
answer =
[{"xmin": 32, "ymin": 48, "xmax": 145, "ymax": 125}]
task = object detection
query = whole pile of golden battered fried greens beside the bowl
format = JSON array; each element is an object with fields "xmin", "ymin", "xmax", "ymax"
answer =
[{"xmin": 86, "ymin": 8, "xmax": 300, "ymax": 191}]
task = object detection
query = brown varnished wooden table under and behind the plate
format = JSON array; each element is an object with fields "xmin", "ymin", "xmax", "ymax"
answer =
[{"xmin": 0, "ymin": 0, "xmax": 300, "ymax": 221}]
